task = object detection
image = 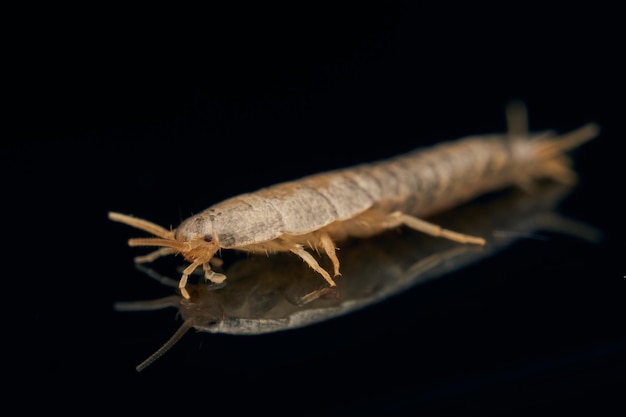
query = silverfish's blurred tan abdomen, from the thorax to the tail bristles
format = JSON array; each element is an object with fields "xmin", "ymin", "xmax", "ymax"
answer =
[{"xmin": 354, "ymin": 136, "xmax": 529, "ymax": 217}]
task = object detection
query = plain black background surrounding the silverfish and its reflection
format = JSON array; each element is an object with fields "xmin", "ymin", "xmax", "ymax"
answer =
[{"xmin": 6, "ymin": 2, "xmax": 626, "ymax": 415}]
